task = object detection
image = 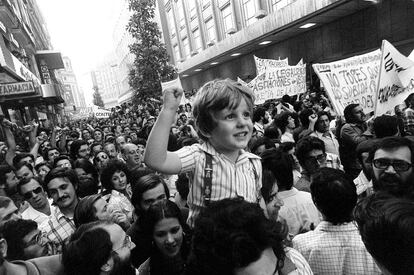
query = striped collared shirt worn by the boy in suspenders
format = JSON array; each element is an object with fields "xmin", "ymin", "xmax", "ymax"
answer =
[{"xmin": 176, "ymin": 142, "xmax": 262, "ymax": 226}]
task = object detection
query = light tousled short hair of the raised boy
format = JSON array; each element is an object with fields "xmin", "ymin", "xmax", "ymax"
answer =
[{"xmin": 193, "ymin": 78, "xmax": 254, "ymax": 140}]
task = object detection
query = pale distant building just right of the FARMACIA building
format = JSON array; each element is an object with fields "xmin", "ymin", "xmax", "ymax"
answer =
[{"xmin": 56, "ymin": 56, "xmax": 86, "ymax": 112}]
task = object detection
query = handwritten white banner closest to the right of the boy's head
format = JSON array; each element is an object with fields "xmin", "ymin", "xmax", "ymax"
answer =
[{"xmin": 247, "ymin": 65, "xmax": 306, "ymax": 105}]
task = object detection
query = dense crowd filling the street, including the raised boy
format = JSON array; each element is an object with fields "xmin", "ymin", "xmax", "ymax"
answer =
[{"xmin": 0, "ymin": 79, "xmax": 414, "ymax": 275}]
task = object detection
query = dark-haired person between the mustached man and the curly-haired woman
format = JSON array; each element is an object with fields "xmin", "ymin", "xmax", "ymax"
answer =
[{"xmin": 73, "ymin": 159, "xmax": 99, "ymax": 198}]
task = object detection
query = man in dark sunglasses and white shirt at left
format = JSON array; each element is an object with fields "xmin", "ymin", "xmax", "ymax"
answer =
[{"xmin": 17, "ymin": 178, "xmax": 54, "ymax": 225}]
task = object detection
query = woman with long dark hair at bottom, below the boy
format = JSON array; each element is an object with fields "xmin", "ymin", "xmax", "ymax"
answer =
[{"xmin": 138, "ymin": 200, "xmax": 190, "ymax": 275}]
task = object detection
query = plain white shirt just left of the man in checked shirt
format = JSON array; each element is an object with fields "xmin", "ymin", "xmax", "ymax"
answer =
[{"xmin": 277, "ymin": 190, "xmax": 321, "ymax": 236}]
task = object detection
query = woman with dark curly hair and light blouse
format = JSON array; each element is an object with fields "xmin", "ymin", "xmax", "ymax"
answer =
[{"xmin": 101, "ymin": 159, "xmax": 134, "ymax": 223}]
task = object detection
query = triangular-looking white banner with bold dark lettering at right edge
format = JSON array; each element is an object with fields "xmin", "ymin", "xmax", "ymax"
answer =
[{"xmin": 375, "ymin": 40, "xmax": 414, "ymax": 116}]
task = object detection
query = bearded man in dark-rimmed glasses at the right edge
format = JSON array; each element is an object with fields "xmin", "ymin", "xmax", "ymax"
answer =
[{"xmin": 369, "ymin": 137, "xmax": 414, "ymax": 197}]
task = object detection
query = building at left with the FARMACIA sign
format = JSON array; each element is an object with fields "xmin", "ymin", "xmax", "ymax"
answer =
[{"xmin": 0, "ymin": 0, "xmax": 64, "ymax": 123}]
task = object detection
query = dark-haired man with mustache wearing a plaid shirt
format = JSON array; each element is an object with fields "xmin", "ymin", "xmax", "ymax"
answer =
[{"xmin": 39, "ymin": 168, "xmax": 79, "ymax": 253}]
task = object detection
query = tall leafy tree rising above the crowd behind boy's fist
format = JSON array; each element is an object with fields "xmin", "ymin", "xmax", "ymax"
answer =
[{"xmin": 127, "ymin": 0, "xmax": 176, "ymax": 104}]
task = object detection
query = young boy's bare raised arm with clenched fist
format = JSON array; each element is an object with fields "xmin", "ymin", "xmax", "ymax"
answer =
[{"xmin": 144, "ymin": 89, "xmax": 183, "ymax": 174}]
